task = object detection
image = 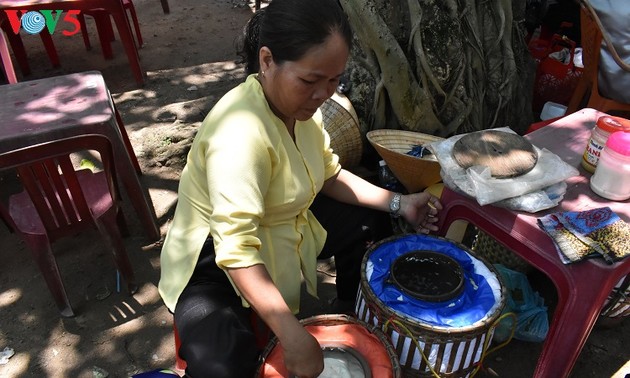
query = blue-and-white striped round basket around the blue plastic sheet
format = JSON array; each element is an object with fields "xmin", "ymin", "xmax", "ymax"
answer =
[{"xmin": 355, "ymin": 235, "xmax": 507, "ymax": 378}]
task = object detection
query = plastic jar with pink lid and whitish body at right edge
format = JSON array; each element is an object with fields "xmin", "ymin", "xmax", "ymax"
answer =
[{"xmin": 591, "ymin": 131, "xmax": 630, "ymax": 201}]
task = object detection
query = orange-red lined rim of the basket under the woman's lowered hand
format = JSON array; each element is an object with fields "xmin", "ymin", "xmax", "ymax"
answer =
[{"xmin": 256, "ymin": 314, "xmax": 402, "ymax": 378}]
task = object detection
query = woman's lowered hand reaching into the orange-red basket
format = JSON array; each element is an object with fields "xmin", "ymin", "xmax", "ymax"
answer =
[{"xmin": 280, "ymin": 324, "xmax": 324, "ymax": 378}]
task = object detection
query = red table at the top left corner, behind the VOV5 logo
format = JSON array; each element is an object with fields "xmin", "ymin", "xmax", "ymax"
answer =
[{"xmin": 0, "ymin": 0, "xmax": 144, "ymax": 86}]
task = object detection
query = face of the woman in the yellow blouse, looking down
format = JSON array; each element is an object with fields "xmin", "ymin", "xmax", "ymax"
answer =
[{"xmin": 259, "ymin": 33, "xmax": 349, "ymax": 123}]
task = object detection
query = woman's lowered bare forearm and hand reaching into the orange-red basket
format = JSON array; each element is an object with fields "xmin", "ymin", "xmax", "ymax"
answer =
[{"xmin": 227, "ymin": 264, "xmax": 324, "ymax": 378}]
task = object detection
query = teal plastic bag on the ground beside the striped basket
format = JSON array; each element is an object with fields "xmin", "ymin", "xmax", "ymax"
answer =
[{"xmin": 493, "ymin": 264, "xmax": 549, "ymax": 343}]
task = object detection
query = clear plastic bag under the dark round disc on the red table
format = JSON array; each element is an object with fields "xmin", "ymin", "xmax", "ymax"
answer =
[{"xmin": 429, "ymin": 127, "xmax": 579, "ymax": 212}]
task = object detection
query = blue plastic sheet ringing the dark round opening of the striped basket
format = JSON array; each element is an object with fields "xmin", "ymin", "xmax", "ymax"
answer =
[{"xmin": 366, "ymin": 235, "xmax": 498, "ymax": 328}]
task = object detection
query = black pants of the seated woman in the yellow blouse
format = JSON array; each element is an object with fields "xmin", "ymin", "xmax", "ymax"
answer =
[{"xmin": 175, "ymin": 195, "xmax": 392, "ymax": 378}]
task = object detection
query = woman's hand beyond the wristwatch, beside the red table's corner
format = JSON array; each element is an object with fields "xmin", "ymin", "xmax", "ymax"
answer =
[{"xmin": 399, "ymin": 192, "xmax": 442, "ymax": 234}]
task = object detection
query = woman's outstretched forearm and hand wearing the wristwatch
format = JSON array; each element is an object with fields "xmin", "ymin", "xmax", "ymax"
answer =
[{"xmin": 322, "ymin": 169, "xmax": 442, "ymax": 233}]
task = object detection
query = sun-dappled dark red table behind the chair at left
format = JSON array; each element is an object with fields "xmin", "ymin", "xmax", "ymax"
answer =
[{"xmin": 0, "ymin": 71, "xmax": 160, "ymax": 241}]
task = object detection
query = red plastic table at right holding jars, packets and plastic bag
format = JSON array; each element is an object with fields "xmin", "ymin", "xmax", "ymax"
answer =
[{"xmin": 438, "ymin": 109, "xmax": 630, "ymax": 378}]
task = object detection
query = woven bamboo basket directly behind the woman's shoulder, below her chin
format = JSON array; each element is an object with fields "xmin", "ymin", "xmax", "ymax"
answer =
[{"xmin": 320, "ymin": 92, "xmax": 363, "ymax": 168}]
